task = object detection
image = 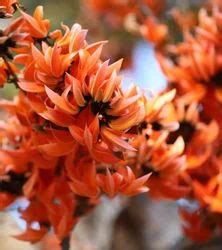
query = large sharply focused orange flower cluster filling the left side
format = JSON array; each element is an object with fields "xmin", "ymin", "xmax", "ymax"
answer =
[{"xmin": 0, "ymin": 2, "xmax": 177, "ymax": 248}]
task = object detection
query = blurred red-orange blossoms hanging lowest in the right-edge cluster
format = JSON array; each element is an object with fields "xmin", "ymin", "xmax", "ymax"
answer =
[{"xmin": 180, "ymin": 157, "xmax": 222, "ymax": 242}]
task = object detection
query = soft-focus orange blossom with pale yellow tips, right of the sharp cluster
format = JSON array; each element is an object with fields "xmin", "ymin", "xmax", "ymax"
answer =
[{"xmin": 127, "ymin": 129, "xmax": 190, "ymax": 199}]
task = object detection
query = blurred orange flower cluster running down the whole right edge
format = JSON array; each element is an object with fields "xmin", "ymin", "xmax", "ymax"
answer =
[{"xmin": 154, "ymin": 4, "xmax": 222, "ymax": 241}]
